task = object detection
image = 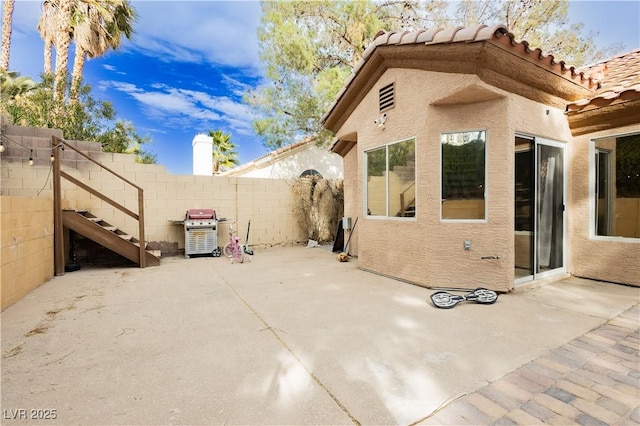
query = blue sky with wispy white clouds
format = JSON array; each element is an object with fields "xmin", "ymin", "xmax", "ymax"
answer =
[{"xmin": 9, "ymin": 0, "xmax": 640, "ymax": 174}]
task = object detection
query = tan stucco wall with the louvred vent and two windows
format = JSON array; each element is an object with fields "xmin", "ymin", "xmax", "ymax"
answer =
[{"xmin": 337, "ymin": 69, "xmax": 570, "ymax": 291}]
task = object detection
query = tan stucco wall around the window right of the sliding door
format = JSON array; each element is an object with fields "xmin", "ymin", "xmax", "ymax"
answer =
[{"xmin": 569, "ymin": 124, "xmax": 640, "ymax": 286}]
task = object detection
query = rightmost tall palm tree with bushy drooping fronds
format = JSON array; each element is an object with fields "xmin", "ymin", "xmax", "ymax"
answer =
[{"xmin": 71, "ymin": 0, "xmax": 136, "ymax": 99}]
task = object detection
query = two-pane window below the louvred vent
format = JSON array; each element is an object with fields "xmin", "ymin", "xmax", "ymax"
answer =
[{"xmin": 365, "ymin": 139, "xmax": 416, "ymax": 217}]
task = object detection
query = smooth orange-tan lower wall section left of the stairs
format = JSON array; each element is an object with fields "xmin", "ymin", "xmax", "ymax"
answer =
[{"xmin": 0, "ymin": 196, "xmax": 53, "ymax": 309}]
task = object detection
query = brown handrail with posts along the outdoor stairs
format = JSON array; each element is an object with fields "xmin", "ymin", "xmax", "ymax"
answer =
[{"xmin": 51, "ymin": 136, "xmax": 147, "ymax": 275}]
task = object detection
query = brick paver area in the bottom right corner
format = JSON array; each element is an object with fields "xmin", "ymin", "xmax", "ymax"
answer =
[{"xmin": 423, "ymin": 304, "xmax": 640, "ymax": 426}]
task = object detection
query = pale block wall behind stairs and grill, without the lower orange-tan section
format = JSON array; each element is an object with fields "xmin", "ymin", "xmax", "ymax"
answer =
[{"xmin": 1, "ymin": 126, "xmax": 304, "ymax": 253}]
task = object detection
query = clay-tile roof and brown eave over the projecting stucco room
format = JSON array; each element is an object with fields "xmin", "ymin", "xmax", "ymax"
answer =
[{"xmin": 321, "ymin": 25, "xmax": 598, "ymax": 131}]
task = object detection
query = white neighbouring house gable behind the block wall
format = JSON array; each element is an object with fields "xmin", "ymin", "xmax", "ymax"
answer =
[{"xmin": 221, "ymin": 138, "xmax": 343, "ymax": 179}]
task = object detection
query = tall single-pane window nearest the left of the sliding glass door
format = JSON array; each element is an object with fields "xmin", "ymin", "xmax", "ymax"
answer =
[{"xmin": 440, "ymin": 130, "xmax": 487, "ymax": 219}]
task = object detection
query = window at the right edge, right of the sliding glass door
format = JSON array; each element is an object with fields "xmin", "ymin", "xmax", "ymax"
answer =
[{"xmin": 594, "ymin": 134, "xmax": 640, "ymax": 238}]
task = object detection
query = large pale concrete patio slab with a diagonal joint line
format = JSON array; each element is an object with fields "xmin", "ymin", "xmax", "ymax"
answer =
[{"xmin": 2, "ymin": 247, "xmax": 640, "ymax": 425}]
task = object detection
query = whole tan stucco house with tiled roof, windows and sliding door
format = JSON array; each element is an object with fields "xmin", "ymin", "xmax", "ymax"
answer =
[{"xmin": 322, "ymin": 25, "xmax": 640, "ymax": 291}]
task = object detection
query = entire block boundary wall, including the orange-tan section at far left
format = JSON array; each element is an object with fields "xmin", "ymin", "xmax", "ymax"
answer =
[{"xmin": 0, "ymin": 125, "xmax": 306, "ymax": 309}]
